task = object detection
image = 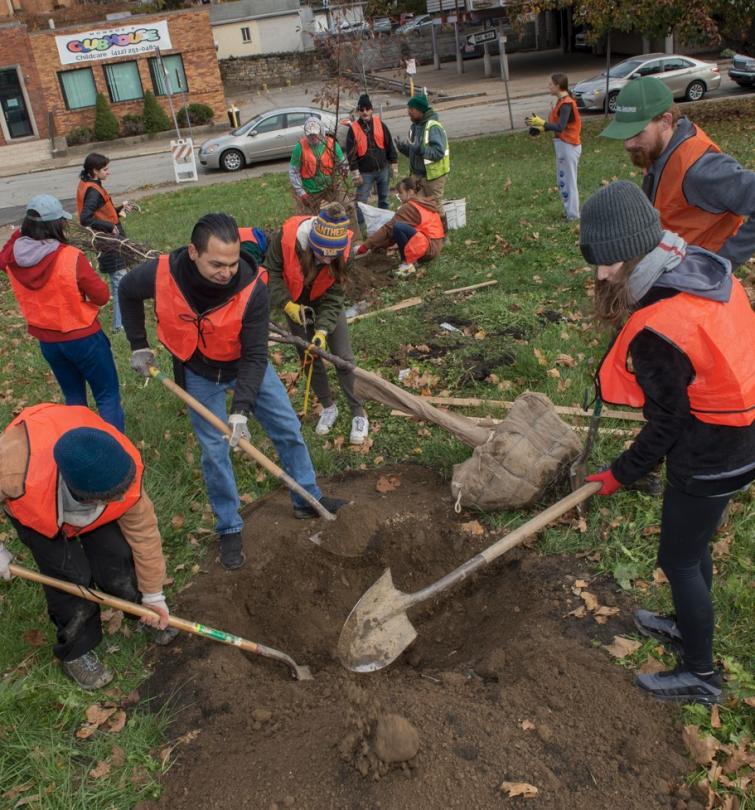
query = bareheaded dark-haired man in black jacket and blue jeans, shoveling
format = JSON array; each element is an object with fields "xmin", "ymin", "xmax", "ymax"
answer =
[{"xmin": 119, "ymin": 214, "xmax": 345, "ymax": 569}]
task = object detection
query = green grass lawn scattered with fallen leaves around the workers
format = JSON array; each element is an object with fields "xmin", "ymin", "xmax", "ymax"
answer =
[{"xmin": 0, "ymin": 110, "xmax": 755, "ymax": 810}]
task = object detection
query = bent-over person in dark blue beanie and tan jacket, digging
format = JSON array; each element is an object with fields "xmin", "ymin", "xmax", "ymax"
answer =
[{"xmin": 0, "ymin": 403, "xmax": 178, "ymax": 690}]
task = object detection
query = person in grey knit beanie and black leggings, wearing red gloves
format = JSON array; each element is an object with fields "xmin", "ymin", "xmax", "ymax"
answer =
[{"xmin": 580, "ymin": 182, "xmax": 755, "ymax": 703}]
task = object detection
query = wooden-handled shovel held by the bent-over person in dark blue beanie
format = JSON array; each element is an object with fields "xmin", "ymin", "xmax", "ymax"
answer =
[{"xmin": 9, "ymin": 563, "xmax": 312, "ymax": 681}]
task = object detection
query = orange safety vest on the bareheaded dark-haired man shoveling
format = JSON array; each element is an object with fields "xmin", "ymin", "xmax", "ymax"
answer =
[{"xmin": 155, "ymin": 255, "xmax": 267, "ymax": 363}]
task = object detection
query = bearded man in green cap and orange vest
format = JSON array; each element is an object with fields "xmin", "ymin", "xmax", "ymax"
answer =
[{"xmin": 601, "ymin": 76, "xmax": 755, "ymax": 268}]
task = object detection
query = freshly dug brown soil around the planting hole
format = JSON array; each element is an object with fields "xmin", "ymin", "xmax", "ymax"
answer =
[{"xmin": 140, "ymin": 466, "xmax": 700, "ymax": 810}]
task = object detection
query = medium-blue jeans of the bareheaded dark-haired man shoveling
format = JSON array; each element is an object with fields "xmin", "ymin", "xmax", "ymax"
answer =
[{"xmin": 185, "ymin": 363, "xmax": 321, "ymax": 535}]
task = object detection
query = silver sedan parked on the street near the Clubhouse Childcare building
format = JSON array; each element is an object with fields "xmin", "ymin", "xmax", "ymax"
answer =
[{"xmin": 199, "ymin": 107, "xmax": 336, "ymax": 172}]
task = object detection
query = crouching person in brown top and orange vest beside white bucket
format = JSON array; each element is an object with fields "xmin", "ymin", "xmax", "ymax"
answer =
[{"xmin": 357, "ymin": 177, "xmax": 446, "ymax": 278}]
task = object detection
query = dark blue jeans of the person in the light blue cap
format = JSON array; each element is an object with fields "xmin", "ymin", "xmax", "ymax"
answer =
[{"xmin": 39, "ymin": 329, "xmax": 125, "ymax": 432}]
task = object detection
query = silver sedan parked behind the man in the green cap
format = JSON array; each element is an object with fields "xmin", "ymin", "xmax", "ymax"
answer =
[{"xmin": 572, "ymin": 53, "xmax": 721, "ymax": 112}]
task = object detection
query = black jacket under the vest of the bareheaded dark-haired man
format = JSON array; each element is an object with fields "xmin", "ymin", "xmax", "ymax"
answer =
[{"xmin": 118, "ymin": 248, "xmax": 269, "ymax": 414}]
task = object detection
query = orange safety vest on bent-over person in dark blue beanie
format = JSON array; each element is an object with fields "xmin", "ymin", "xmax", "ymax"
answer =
[{"xmin": 5, "ymin": 402, "xmax": 144, "ymax": 538}]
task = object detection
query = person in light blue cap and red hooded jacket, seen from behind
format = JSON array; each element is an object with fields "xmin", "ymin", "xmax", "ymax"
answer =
[{"xmin": 0, "ymin": 194, "xmax": 124, "ymax": 431}]
